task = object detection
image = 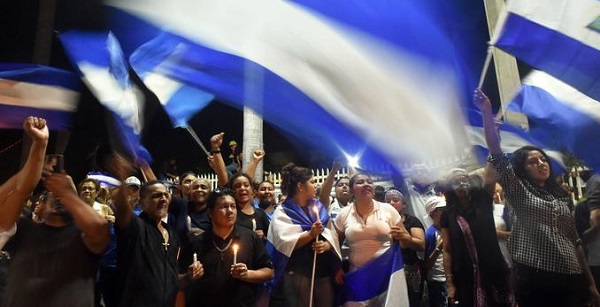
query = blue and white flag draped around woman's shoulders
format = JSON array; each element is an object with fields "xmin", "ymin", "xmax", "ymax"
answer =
[{"xmin": 267, "ymin": 197, "xmax": 342, "ymax": 285}]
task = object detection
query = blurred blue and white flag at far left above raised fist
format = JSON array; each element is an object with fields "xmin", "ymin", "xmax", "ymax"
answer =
[{"xmin": 0, "ymin": 63, "xmax": 81, "ymax": 130}]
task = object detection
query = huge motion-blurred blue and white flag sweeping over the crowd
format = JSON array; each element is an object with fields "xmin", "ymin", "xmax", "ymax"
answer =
[{"xmin": 106, "ymin": 0, "xmax": 468, "ymax": 173}]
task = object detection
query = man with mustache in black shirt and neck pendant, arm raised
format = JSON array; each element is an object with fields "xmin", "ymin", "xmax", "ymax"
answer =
[{"xmin": 115, "ymin": 181, "xmax": 203, "ymax": 307}]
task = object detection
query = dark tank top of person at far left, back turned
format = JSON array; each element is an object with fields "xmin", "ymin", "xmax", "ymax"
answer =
[{"xmin": 3, "ymin": 219, "xmax": 100, "ymax": 307}]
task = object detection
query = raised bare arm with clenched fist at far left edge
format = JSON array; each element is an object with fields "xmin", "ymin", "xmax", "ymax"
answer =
[{"xmin": 0, "ymin": 116, "xmax": 49, "ymax": 230}]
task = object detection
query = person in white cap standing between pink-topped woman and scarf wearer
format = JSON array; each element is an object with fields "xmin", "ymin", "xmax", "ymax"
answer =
[{"xmin": 425, "ymin": 196, "xmax": 448, "ymax": 307}]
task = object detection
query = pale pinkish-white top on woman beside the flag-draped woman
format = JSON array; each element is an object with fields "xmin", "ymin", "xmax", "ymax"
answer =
[{"xmin": 334, "ymin": 200, "xmax": 401, "ymax": 271}]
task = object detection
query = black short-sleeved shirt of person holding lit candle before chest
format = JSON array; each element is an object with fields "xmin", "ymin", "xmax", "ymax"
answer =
[{"xmin": 186, "ymin": 226, "xmax": 273, "ymax": 307}]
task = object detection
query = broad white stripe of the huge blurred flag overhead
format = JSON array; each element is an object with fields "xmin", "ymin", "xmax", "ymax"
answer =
[{"xmin": 108, "ymin": 0, "xmax": 467, "ymax": 165}]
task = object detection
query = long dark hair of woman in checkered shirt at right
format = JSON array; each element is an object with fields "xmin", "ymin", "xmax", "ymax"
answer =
[{"xmin": 510, "ymin": 145, "xmax": 569, "ymax": 198}]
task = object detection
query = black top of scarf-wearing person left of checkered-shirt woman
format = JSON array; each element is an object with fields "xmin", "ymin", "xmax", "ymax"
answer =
[{"xmin": 441, "ymin": 188, "xmax": 508, "ymax": 283}]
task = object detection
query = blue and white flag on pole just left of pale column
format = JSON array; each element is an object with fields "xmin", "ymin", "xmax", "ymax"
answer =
[{"xmin": 130, "ymin": 33, "xmax": 215, "ymax": 128}]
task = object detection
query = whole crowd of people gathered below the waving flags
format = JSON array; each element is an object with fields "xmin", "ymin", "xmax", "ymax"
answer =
[{"xmin": 0, "ymin": 90, "xmax": 600, "ymax": 307}]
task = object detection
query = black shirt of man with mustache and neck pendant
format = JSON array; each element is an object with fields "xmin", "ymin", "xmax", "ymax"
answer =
[{"xmin": 117, "ymin": 212, "xmax": 180, "ymax": 307}]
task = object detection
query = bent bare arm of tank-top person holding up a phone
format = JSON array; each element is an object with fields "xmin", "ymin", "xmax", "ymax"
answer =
[{"xmin": 44, "ymin": 172, "xmax": 110, "ymax": 254}]
